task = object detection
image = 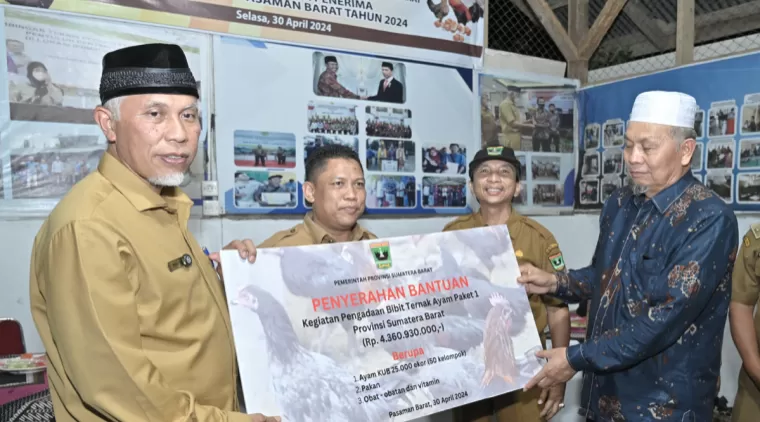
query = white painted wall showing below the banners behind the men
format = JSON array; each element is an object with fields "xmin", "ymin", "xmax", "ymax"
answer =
[{"xmin": 0, "ymin": 214, "xmax": 758, "ymax": 422}]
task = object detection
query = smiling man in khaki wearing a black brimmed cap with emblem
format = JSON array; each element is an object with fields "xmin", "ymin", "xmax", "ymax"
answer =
[{"xmin": 443, "ymin": 147, "xmax": 570, "ymax": 422}]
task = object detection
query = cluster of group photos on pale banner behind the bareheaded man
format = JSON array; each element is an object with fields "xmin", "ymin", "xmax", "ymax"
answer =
[{"xmin": 234, "ymin": 52, "xmax": 469, "ymax": 210}]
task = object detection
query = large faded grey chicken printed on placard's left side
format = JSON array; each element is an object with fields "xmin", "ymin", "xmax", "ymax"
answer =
[{"xmin": 231, "ymin": 286, "xmax": 413, "ymax": 422}]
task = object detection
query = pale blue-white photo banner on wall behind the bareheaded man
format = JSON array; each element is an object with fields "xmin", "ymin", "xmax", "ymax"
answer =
[{"xmin": 214, "ymin": 36, "xmax": 478, "ymax": 214}]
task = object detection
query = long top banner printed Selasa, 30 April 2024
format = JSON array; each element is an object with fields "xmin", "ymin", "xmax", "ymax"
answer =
[{"xmin": 0, "ymin": 0, "xmax": 487, "ymax": 68}]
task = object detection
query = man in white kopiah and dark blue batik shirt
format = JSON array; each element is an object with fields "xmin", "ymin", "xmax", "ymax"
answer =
[{"xmin": 518, "ymin": 91, "xmax": 738, "ymax": 421}]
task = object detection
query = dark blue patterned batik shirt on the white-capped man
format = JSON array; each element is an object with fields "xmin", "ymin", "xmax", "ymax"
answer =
[{"xmin": 556, "ymin": 173, "xmax": 739, "ymax": 422}]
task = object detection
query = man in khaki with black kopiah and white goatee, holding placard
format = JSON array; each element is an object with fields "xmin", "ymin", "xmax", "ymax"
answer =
[{"xmin": 30, "ymin": 44, "xmax": 279, "ymax": 422}]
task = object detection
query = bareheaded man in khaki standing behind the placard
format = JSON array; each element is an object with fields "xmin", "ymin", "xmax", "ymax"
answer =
[{"xmin": 259, "ymin": 144, "xmax": 377, "ymax": 248}]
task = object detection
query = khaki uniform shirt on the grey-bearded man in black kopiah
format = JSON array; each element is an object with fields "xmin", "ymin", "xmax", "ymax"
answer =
[{"xmin": 30, "ymin": 153, "xmax": 250, "ymax": 422}]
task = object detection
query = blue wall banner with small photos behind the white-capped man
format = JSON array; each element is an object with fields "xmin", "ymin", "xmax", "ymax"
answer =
[{"xmin": 576, "ymin": 53, "xmax": 760, "ymax": 212}]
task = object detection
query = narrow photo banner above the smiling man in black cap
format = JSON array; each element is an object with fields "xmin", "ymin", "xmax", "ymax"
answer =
[{"xmin": 478, "ymin": 73, "xmax": 577, "ymax": 215}]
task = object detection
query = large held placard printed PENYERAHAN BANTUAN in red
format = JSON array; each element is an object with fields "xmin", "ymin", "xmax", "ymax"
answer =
[{"xmin": 222, "ymin": 225, "xmax": 541, "ymax": 422}]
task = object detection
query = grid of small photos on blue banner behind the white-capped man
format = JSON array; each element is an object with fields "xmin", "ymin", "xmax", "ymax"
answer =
[{"xmin": 579, "ymin": 93, "xmax": 760, "ymax": 209}]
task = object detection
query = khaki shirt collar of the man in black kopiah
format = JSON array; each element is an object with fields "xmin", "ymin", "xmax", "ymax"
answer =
[{"xmin": 98, "ymin": 152, "xmax": 193, "ymax": 217}]
